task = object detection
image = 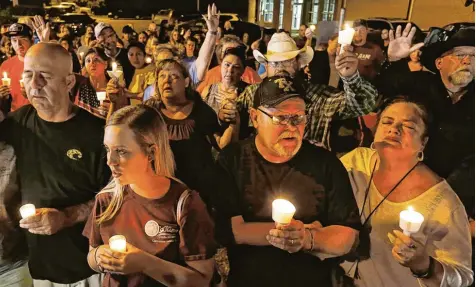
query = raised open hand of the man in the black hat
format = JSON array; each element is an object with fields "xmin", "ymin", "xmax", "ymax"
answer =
[{"xmin": 387, "ymin": 23, "xmax": 424, "ymax": 62}]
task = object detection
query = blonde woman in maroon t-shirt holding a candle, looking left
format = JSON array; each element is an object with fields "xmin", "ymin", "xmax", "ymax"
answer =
[{"xmin": 83, "ymin": 104, "xmax": 216, "ymax": 287}]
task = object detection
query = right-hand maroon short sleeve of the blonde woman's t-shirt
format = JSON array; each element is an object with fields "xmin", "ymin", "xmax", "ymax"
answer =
[{"xmin": 179, "ymin": 191, "xmax": 217, "ymax": 261}]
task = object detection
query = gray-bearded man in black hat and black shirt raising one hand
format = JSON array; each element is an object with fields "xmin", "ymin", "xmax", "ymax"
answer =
[{"xmin": 377, "ymin": 25, "xmax": 475, "ymax": 179}]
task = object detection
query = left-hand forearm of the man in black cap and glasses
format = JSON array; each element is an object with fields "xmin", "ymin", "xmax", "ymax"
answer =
[{"xmin": 231, "ymin": 216, "xmax": 275, "ymax": 246}]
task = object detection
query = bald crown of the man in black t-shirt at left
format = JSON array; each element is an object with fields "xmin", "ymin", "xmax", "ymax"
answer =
[{"xmin": 25, "ymin": 42, "xmax": 73, "ymax": 76}]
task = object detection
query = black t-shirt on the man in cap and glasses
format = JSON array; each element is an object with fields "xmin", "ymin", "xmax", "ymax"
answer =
[{"xmin": 217, "ymin": 138, "xmax": 361, "ymax": 287}]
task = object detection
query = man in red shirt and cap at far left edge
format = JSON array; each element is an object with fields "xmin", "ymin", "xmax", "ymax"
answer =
[{"xmin": 0, "ymin": 23, "xmax": 33, "ymax": 111}]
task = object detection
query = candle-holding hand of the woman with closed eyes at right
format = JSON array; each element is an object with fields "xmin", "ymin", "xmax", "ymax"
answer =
[{"xmin": 392, "ymin": 230, "xmax": 430, "ymax": 273}]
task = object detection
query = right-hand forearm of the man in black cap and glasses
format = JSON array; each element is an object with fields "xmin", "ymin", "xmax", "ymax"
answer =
[{"xmin": 305, "ymin": 225, "xmax": 359, "ymax": 256}]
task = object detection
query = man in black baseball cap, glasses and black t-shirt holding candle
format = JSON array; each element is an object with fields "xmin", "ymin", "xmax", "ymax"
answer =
[{"xmin": 215, "ymin": 77, "xmax": 360, "ymax": 287}]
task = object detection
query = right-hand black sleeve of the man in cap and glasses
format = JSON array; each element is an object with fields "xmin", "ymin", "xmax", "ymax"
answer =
[{"xmin": 323, "ymin": 153, "xmax": 362, "ymax": 230}]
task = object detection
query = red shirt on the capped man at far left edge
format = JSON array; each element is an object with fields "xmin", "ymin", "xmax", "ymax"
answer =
[{"xmin": 0, "ymin": 56, "xmax": 30, "ymax": 111}]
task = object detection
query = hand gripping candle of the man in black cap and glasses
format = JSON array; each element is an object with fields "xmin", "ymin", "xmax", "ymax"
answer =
[{"xmin": 266, "ymin": 219, "xmax": 310, "ymax": 253}]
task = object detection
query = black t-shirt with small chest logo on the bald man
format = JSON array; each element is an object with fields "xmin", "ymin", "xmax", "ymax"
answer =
[{"xmin": 0, "ymin": 105, "xmax": 111, "ymax": 284}]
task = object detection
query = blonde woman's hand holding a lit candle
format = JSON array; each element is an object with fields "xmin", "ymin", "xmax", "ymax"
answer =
[{"xmin": 96, "ymin": 243, "xmax": 147, "ymax": 275}]
